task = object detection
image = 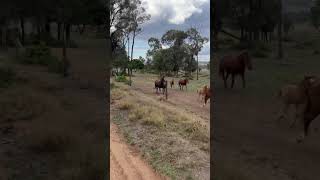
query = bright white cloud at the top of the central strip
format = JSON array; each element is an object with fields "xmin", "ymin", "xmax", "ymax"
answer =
[{"xmin": 142, "ymin": 0, "xmax": 209, "ymax": 24}]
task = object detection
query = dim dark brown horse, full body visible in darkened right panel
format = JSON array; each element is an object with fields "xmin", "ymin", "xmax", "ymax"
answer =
[{"xmin": 219, "ymin": 51, "xmax": 252, "ymax": 88}]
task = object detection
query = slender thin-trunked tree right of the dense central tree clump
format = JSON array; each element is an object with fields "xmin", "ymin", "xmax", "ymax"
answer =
[{"xmin": 187, "ymin": 28, "xmax": 209, "ymax": 80}]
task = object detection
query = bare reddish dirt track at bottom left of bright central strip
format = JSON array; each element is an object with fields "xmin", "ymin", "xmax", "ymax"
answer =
[{"xmin": 110, "ymin": 124, "xmax": 165, "ymax": 180}]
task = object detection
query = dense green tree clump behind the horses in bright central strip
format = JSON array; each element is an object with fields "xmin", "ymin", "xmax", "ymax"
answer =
[{"xmin": 146, "ymin": 28, "xmax": 208, "ymax": 74}]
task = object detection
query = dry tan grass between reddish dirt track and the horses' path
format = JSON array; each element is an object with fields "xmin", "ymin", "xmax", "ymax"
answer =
[{"xmin": 113, "ymin": 83, "xmax": 209, "ymax": 179}]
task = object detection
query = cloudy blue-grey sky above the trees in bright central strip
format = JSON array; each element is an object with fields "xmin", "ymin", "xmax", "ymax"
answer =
[{"xmin": 133, "ymin": 0, "xmax": 210, "ymax": 61}]
